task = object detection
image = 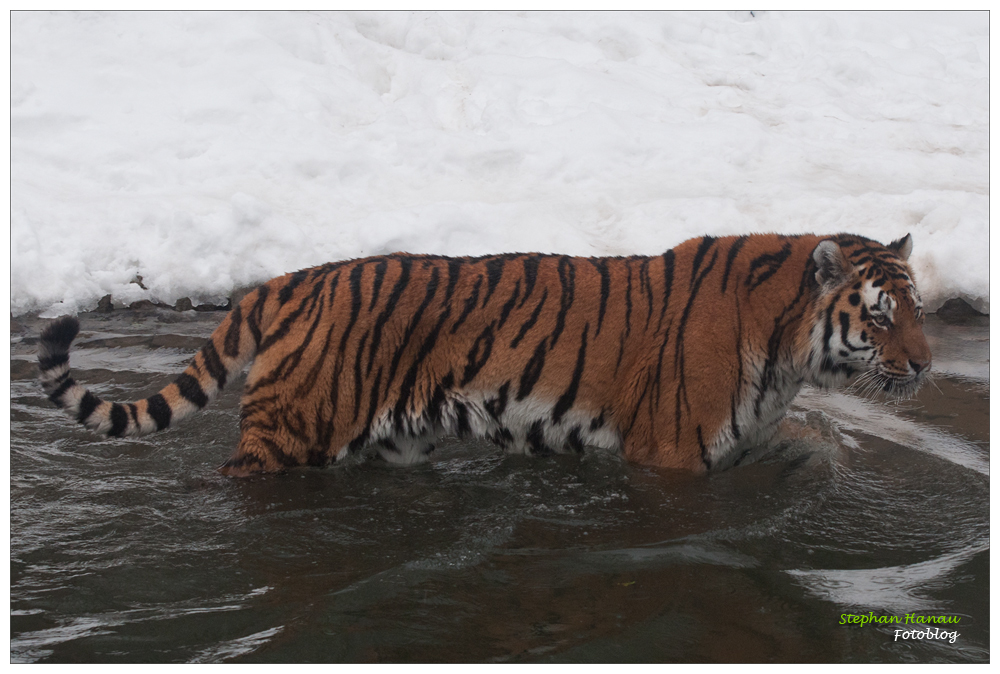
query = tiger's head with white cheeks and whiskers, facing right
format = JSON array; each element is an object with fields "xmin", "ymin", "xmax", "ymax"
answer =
[{"xmin": 809, "ymin": 234, "xmax": 931, "ymax": 398}]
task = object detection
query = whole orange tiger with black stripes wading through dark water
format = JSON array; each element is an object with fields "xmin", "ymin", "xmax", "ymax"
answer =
[{"xmin": 38, "ymin": 234, "xmax": 931, "ymax": 477}]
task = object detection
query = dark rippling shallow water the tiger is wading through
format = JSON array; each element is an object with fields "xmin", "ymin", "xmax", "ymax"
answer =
[{"xmin": 10, "ymin": 311, "xmax": 989, "ymax": 662}]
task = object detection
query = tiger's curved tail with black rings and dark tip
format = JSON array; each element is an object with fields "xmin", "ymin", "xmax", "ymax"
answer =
[{"xmin": 38, "ymin": 293, "xmax": 259, "ymax": 437}]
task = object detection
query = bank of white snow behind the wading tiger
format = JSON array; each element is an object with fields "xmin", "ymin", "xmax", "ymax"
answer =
[{"xmin": 10, "ymin": 12, "xmax": 989, "ymax": 316}]
